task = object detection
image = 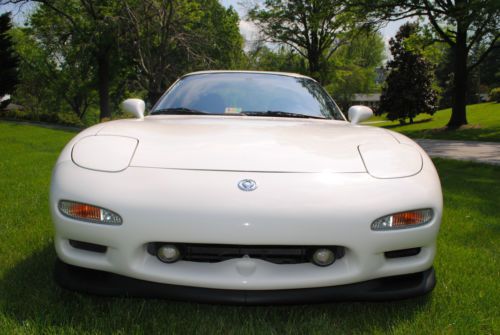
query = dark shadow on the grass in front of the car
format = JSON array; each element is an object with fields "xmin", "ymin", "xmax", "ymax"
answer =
[{"xmin": 0, "ymin": 245, "xmax": 431, "ymax": 334}]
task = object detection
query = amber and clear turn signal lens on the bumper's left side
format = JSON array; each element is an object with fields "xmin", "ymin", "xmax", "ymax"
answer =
[{"xmin": 58, "ymin": 200, "xmax": 122, "ymax": 225}]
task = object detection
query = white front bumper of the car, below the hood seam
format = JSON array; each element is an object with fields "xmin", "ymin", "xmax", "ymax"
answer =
[{"xmin": 51, "ymin": 161, "xmax": 442, "ymax": 292}]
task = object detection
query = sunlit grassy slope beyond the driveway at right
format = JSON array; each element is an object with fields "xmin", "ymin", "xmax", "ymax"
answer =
[{"xmin": 367, "ymin": 102, "xmax": 500, "ymax": 142}]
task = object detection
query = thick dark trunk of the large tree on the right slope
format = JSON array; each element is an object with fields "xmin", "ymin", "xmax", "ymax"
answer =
[{"xmin": 448, "ymin": 16, "xmax": 468, "ymax": 128}]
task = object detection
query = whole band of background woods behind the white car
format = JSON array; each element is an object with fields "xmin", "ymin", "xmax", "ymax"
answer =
[{"xmin": 0, "ymin": 0, "xmax": 500, "ymax": 128}]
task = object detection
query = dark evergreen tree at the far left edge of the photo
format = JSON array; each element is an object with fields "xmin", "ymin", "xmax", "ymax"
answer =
[{"xmin": 0, "ymin": 13, "xmax": 19, "ymax": 107}]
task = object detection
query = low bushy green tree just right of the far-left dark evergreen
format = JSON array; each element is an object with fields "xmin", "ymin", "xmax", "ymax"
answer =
[{"xmin": 12, "ymin": 25, "xmax": 95, "ymax": 122}]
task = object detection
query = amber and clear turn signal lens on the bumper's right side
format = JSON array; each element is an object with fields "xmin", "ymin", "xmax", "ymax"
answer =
[{"xmin": 371, "ymin": 208, "xmax": 434, "ymax": 230}]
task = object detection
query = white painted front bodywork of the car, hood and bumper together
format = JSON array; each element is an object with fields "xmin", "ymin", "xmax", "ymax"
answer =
[{"xmin": 50, "ymin": 71, "xmax": 442, "ymax": 290}]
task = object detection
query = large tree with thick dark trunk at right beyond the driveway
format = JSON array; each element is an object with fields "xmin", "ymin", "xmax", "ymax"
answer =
[{"xmin": 350, "ymin": 0, "xmax": 500, "ymax": 128}]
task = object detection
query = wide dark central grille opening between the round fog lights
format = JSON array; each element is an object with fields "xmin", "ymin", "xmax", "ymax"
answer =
[{"xmin": 147, "ymin": 242, "xmax": 345, "ymax": 264}]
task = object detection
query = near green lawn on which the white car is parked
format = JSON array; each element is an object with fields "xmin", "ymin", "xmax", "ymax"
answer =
[{"xmin": 0, "ymin": 122, "xmax": 500, "ymax": 334}]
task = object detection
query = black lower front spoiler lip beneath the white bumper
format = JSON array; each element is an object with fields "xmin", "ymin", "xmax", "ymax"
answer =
[{"xmin": 54, "ymin": 259, "xmax": 436, "ymax": 305}]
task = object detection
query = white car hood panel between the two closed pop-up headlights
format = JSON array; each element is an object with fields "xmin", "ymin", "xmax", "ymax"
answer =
[{"xmin": 98, "ymin": 116, "xmax": 398, "ymax": 173}]
